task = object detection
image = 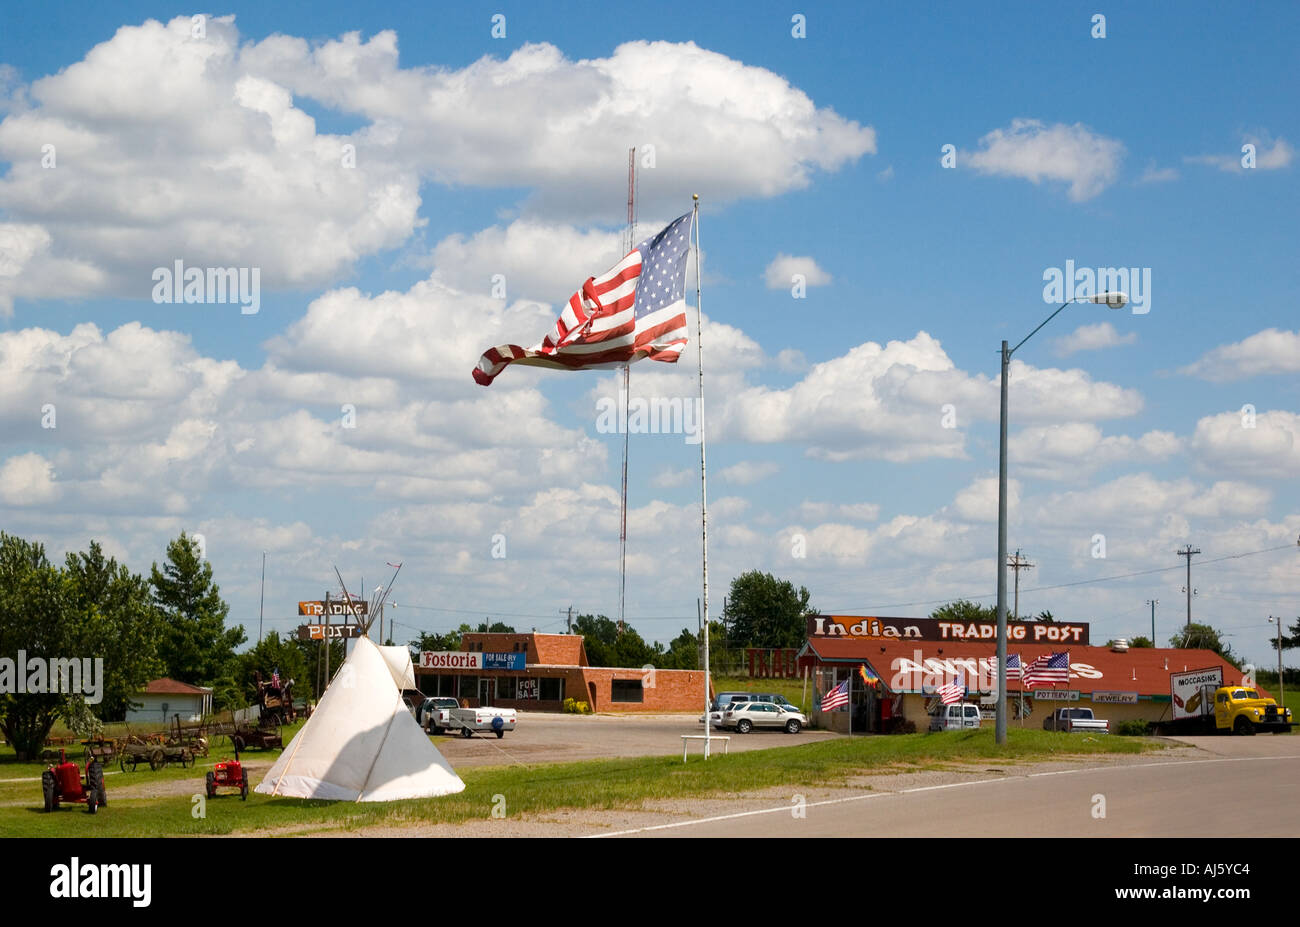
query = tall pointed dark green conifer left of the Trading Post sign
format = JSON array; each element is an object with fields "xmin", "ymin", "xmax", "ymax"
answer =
[{"xmin": 150, "ymin": 532, "xmax": 247, "ymax": 691}]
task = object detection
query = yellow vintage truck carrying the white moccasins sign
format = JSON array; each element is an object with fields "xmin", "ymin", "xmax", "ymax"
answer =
[{"xmin": 1151, "ymin": 667, "xmax": 1291, "ymax": 735}]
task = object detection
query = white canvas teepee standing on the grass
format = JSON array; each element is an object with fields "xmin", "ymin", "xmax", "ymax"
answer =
[{"xmin": 255, "ymin": 637, "xmax": 465, "ymax": 801}]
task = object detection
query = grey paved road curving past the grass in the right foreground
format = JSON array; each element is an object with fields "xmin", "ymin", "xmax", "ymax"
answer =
[{"xmin": 608, "ymin": 735, "xmax": 1300, "ymax": 837}]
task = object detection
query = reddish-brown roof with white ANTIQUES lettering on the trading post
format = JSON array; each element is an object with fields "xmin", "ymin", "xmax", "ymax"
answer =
[{"xmin": 800, "ymin": 637, "xmax": 1268, "ymax": 698}]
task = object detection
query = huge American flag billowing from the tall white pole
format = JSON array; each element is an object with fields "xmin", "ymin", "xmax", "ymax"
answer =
[{"xmin": 473, "ymin": 212, "xmax": 693, "ymax": 386}]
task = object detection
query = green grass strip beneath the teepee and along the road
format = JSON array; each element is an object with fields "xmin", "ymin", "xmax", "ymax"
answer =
[{"xmin": 0, "ymin": 728, "xmax": 1161, "ymax": 837}]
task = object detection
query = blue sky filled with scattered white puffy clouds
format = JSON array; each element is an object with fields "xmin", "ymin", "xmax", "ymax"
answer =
[{"xmin": 0, "ymin": 4, "xmax": 1300, "ymax": 662}]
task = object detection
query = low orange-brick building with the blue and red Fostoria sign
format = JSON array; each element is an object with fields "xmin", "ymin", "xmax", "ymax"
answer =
[{"xmin": 415, "ymin": 632, "xmax": 705, "ymax": 712}]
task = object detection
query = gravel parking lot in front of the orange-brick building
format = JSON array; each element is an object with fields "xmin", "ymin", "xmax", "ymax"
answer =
[{"xmin": 433, "ymin": 712, "xmax": 842, "ymax": 768}]
